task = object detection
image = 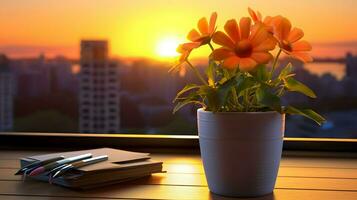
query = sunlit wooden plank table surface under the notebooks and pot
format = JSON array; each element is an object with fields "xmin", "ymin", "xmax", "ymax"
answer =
[{"xmin": 0, "ymin": 150, "xmax": 357, "ymax": 200}]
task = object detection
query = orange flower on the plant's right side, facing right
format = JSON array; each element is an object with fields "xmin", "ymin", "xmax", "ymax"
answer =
[{"xmin": 273, "ymin": 16, "xmax": 312, "ymax": 62}]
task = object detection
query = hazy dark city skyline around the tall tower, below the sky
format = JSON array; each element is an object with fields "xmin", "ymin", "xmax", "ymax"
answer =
[{"xmin": 2, "ymin": 45, "xmax": 357, "ymax": 137}]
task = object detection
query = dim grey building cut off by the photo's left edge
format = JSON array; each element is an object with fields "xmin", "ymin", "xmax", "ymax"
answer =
[{"xmin": 0, "ymin": 55, "xmax": 15, "ymax": 131}]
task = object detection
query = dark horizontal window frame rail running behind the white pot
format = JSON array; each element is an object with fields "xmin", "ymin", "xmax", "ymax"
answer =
[{"xmin": 0, "ymin": 132, "xmax": 357, "ymax": 152}]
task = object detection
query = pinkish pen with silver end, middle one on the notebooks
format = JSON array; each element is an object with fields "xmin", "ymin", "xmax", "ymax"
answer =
[{"xmin": 29, "ymin": 153, "xmax": 92, "ymax": 176}]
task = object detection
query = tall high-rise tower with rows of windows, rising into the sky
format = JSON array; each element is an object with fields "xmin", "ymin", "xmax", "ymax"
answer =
[{"xmin": 79, "ymin": 40, "xmax": 120, "ymax": 133}]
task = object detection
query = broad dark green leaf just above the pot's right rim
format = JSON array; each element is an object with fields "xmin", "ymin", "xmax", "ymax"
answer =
[{"xmin": 256, "ymin": 86, "xmax": 281, "ymax": 112}]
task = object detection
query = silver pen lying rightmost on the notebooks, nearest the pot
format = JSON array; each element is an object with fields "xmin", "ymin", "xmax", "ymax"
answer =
[{"xmin": 50, "ymin": 155, "xmax": 108, "ymax": 179}]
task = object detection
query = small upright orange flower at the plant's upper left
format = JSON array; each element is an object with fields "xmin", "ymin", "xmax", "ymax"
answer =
[{"xmin": 187, "ymin": 12, "xmax": 217, "ymax": 45}]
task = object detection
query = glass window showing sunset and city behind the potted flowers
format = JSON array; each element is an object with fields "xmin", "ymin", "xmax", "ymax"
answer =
[{"xmin": 0, "ymin": 0, "xmax": 357, "ymax": 138}]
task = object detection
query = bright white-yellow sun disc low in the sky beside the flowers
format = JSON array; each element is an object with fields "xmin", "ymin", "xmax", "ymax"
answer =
[{"xmin": 156, "ymin": 37, "xmax": 181, "ymax": 58}]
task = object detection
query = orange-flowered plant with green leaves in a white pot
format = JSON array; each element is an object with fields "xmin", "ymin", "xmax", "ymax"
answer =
[{"xmin": 172, "ymin": 9, "xmax": 324, "ymax": 197}]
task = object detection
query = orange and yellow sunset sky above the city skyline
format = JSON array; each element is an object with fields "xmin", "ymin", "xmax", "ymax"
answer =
[{"xmin": 0, "ymin": 0, "xmax": 357, "ymax": 58}]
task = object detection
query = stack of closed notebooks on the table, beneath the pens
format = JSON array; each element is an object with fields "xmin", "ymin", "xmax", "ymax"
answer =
[{"xmin": 20, "ymin": 148, "xmax": 162, "ymax": 189}]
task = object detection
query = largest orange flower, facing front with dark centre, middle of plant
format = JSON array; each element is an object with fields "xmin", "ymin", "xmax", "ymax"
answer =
[{"xmin": 212, "ymin": 17, "xmax": 276, "ymax": 71}]
